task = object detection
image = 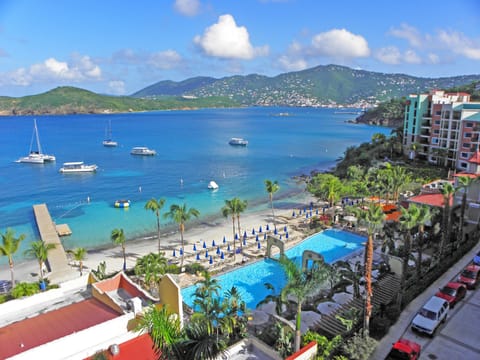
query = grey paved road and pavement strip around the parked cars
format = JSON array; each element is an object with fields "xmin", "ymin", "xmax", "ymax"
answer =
[{"xmin": 372, "ymin": 245, "xmax": 480, "ymax": 360}]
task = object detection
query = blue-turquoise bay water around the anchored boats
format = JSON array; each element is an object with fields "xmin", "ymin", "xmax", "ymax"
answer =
[{"xmin": 0, "ymin": 108, "xmax": 390, "ymax": 262}]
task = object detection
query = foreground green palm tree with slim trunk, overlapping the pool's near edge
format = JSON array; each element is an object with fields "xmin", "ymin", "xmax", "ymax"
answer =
[{"xmin": 279, "ymin": 256, "xmax": 327, "ymax": 351}]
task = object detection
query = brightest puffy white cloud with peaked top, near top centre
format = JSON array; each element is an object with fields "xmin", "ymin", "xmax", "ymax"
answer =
[{"xmin": 193, "ymin": 14, "xmax": 269, "ymax": 60}]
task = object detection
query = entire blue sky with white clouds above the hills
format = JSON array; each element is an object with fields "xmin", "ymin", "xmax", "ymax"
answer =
[{"xmin": 0, "ymin": 0, "xmax": 480, "ymax": 97}]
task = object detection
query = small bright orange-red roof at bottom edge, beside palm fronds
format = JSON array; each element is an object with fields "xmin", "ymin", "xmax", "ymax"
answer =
[{"xmin": 84, "ymin": 334, "xmax": 158, "ymax": 360}]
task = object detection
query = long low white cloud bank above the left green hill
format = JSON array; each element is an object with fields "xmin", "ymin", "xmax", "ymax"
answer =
[{"xmin": 0, "ymin": 54, "xmax": 102, "ymax": 86}]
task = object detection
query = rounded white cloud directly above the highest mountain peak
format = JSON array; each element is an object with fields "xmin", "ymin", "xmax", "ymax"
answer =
[{"xmin": 312, "ymin": 29, "xmax": 370, "ymax": 58}]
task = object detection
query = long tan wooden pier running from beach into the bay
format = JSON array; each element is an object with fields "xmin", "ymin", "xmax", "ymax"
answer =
[{"xmin": 33, "ymin": 204, "xmax": 75, "ymax": 283}]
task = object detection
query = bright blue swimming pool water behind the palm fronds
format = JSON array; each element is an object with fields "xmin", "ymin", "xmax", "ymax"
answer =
[{"xmin": 182, "ymin": 229, "xmax": 366, "ymax": 309}]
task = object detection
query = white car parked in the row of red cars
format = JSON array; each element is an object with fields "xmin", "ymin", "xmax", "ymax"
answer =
[{"xmin": 412, "ymin": 296, "xmax": 450, "ymax": 336}]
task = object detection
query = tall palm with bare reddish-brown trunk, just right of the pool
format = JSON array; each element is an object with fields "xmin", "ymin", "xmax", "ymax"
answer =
[{"xmin": 356, "ymin": 203, "xmax": 386, "ymax": 335}]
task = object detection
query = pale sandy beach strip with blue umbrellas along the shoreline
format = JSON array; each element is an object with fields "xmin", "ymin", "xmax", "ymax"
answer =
[{"xmin": 0, "ymin": 193, "xmax": 316, "ymax": 286}]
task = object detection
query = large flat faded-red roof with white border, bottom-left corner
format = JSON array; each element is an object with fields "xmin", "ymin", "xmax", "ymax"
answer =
[{"xmin": 0, "ymin": 299, "xmax": 119, "ymax": 359}]
